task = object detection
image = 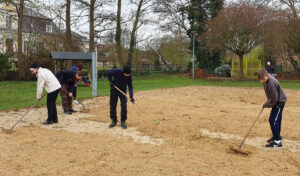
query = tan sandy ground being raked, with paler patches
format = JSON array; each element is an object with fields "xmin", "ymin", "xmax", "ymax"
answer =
[{"xmin": 0, "ymin": 86, "xmax": 300, "ymax": 176}]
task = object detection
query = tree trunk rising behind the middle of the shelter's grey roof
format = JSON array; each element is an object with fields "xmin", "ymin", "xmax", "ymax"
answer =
[{"xmin": 64, "ymin": 0, "xmax": 73, "ymax": 70}]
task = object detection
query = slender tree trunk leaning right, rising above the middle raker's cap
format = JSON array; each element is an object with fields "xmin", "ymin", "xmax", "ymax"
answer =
[{"xmin": 127, "ymin": 0, "xmax": 143, "ymax": 66}]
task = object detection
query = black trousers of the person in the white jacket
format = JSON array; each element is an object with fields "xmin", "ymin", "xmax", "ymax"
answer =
[{"xmin": 47, "ymin": 89, "xmax": 60, "ymax": 122}]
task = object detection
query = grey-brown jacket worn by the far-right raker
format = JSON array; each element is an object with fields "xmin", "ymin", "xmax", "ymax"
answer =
[{"xmin": 263, "ymin": 74, "xmax": 287, "ymax": 108}]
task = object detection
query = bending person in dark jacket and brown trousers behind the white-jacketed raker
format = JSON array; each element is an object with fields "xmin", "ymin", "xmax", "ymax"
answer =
[{"xmin": 55, "ymin": 71, "xmax": 83, "ymax": 114}]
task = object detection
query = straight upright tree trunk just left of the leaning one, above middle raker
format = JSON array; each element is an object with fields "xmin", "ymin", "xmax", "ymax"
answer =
[{"xmin": 115, "ymin": 0, "xmax": 124, "ymax": 66}]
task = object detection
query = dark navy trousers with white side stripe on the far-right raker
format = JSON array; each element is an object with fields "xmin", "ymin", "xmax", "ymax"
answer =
[{"xmin": 269, "ymin": 106, "xmax": 284, "ymax": 140}]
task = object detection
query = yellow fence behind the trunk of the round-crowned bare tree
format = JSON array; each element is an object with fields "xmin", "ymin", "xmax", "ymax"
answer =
[{"xmin": 231, "ymin": 58, "xmax": 261, "ymax": 78}]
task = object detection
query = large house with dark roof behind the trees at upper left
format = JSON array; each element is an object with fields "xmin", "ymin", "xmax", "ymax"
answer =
[{"xmin": 0, "ymin": 3, "xmax": 89, "ymax": 61}]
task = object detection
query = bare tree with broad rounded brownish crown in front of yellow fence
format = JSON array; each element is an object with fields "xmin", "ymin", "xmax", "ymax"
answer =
[{"xmin": 207, "ymin": 4, "xmax": 266, "ymax": 78}]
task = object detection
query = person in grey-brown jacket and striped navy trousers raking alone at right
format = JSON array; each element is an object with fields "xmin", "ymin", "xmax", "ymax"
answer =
[{"xmin": 258, "ymin": 68, "xmax": 287, "ymax": 148}]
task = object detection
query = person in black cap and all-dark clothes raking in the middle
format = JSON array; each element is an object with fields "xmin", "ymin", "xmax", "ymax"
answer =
[{"xmin": 107, "ymin": 66, "xmax": 134, "ymax": 129}]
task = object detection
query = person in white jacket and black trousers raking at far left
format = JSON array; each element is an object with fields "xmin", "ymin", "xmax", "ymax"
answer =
[{"xmin": 30, "ymin": 62, "xmax": 61, "ymax": 125}]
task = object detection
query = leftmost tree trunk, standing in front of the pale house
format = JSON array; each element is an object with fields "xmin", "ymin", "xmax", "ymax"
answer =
[{"xmin": 17, "ymin": 0, "xmax": 24, "ymax": 80}]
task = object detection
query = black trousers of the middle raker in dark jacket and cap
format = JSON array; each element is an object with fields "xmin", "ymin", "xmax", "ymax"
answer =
[{"xmin": 110, "ymin": 90, "xmax": 127, "ymax": 122}]
